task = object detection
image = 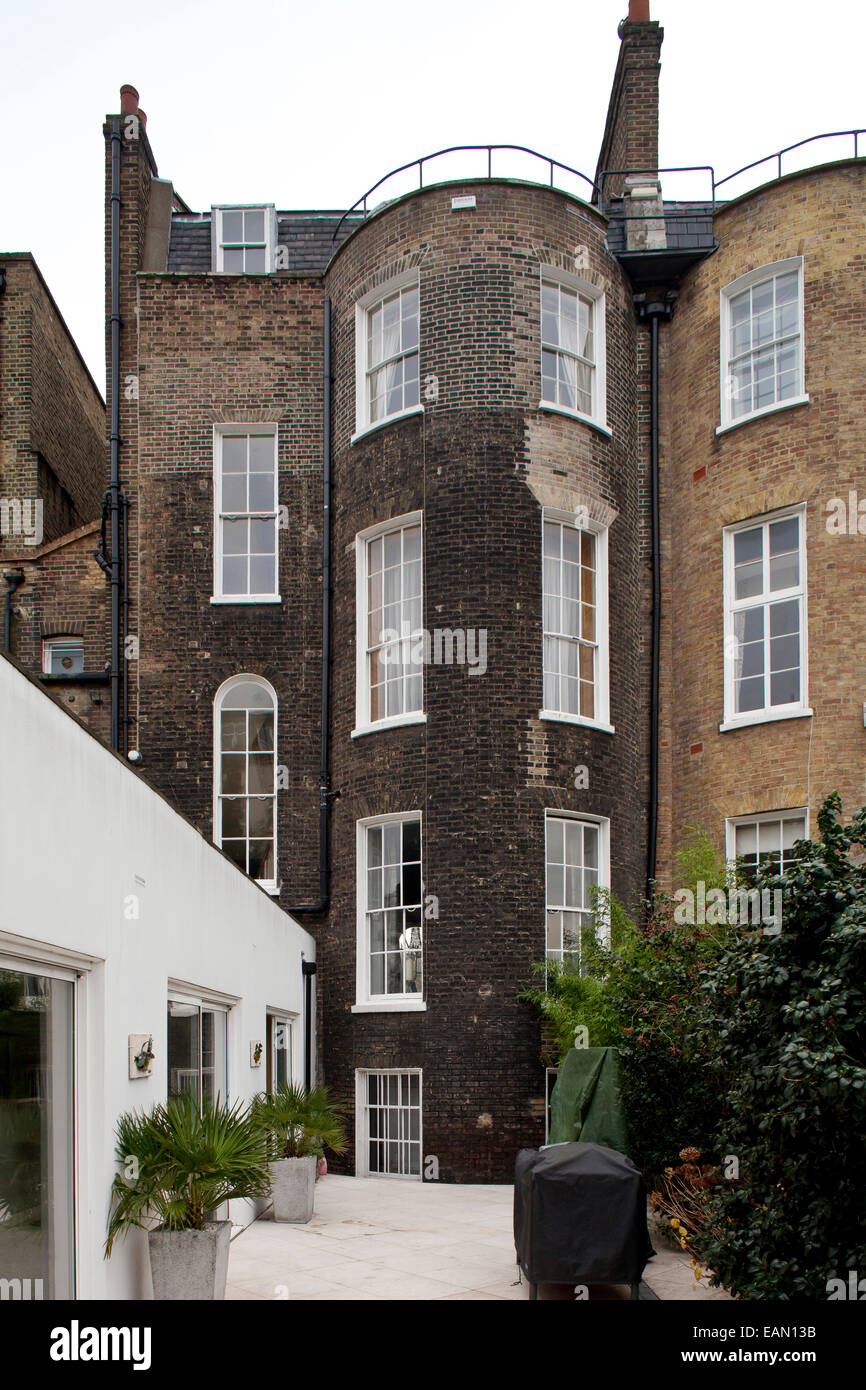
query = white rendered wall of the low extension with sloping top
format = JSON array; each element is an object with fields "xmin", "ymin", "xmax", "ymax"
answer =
[{"xmin": 0, "ymin": 656, "xmax": 316, "ymax": 1298}]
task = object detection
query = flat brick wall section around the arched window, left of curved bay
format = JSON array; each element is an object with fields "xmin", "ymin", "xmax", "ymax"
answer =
[{"xmin": 136, "ymin": 275, "xmax": 324, "ymax": 904}]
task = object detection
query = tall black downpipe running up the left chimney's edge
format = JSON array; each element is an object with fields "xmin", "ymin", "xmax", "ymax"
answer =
[{"xmin": 108, "ymin": 120, "xmax": 122, "ymax": 752}]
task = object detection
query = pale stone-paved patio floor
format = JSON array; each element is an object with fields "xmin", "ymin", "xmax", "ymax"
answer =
[{"xmin": 225, "ymin": 1175, "xmax": 728, "ymax": 1301}]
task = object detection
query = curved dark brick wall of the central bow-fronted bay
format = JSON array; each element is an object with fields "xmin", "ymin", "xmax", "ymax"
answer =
[{"xmin": 318, "ymin": 183, "xmax": 646, "ymax": 1182}]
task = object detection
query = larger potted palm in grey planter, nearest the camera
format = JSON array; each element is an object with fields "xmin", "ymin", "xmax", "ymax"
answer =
[{"xmin": 106, "ymin": 1093, "xmax": 270, "ymax": 1300}]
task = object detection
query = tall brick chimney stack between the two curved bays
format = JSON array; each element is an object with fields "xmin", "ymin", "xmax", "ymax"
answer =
[{"xmin": 595, "ymin": 0, "xmax": 664, "ymax": 202}]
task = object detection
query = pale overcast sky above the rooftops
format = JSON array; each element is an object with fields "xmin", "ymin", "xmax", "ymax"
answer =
[{"xmin": 0, "ymin": 0, "xmax": 866, "ymax": 388}]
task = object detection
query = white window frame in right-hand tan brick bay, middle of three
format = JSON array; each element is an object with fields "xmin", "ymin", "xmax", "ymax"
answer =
[{"xmin": 719, "ymin": 502, "xmax": 813, "ymax": 734}]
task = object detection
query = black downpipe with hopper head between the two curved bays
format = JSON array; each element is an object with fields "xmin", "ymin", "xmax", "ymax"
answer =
[{"xmin": 635, "ymin": 296, "xmax": 674, "ymax": 904}]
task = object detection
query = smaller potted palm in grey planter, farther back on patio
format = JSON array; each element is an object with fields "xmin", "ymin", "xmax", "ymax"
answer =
[{"xmin": 253, "ymin": 1084, "xmax": 346, "ymax": 1222}]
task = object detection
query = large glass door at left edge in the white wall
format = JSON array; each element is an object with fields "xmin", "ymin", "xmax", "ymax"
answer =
[{"xmin": 0, "ymin": 962, "xmax": 75, "ymax": 1298}]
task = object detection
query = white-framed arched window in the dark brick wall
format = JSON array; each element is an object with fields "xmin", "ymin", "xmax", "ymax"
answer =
[{"xmin": 214, "ymin": 676, "xmax": 277, "ymax": 891}]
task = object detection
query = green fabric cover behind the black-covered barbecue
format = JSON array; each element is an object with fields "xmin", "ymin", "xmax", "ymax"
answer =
[{"xmin": 548, "ymin": 1047, "xmax": 628, "ymax": 1154}]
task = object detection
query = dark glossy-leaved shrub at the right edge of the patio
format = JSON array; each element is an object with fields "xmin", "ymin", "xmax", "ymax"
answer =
[{"xmin": 702, "ymin": 794, "xmax": 866, "ymax": 1300}]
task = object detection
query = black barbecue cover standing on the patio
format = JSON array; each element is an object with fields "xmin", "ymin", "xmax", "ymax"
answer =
[{"xmin": 514, "ymin": 1144, "xmax": 655, "ymax": 1284}]
